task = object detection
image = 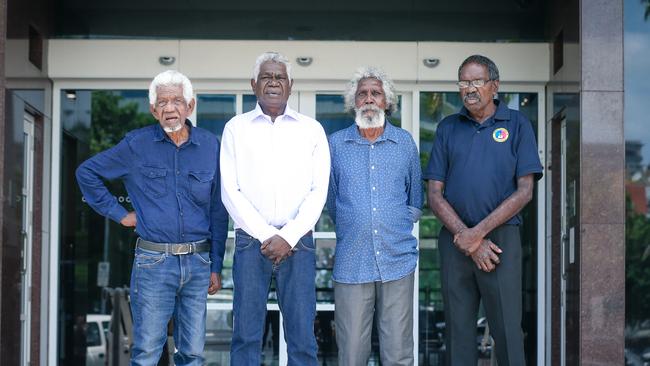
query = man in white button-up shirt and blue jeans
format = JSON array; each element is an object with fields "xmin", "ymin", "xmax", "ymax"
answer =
[{"xmin": 221, "ymin": 52, "xmax": 330, "ymax": 366}]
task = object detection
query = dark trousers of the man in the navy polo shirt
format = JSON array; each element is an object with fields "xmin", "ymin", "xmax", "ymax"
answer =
[{"xmin": 438, "ymin": 225, "xmax": 525, "ymax": 366}]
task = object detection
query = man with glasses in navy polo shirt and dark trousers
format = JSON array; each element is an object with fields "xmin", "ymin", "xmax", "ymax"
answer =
[{"xmin": 424, "ymin": 55, "xmax": 542, "ymax": 366}]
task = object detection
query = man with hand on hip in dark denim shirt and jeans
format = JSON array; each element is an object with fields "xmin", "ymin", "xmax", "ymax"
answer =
[{"xmin": 77, "ymin": 71, "xmax": 228, "ymax": 365}]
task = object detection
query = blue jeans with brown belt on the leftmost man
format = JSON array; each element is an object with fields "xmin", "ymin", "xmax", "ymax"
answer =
[{"xmin": 126, "ymin": 248, "xmax": 210, "ymax": 366}]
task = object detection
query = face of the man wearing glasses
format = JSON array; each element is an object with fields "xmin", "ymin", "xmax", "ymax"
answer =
[{"xmin": 459, "ymin": 64, "xmax": 499, "ymax": 117}]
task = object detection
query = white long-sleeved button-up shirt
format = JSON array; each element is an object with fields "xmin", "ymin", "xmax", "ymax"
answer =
[{"xmin": 221, "ymin": 104, "xmax": 330, "ymax": 247}]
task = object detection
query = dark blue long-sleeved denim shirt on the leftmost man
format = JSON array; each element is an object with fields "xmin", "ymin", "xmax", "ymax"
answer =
[{"xmin": 77, "ymin": 121, "xmax": 228, "ymax": 272}]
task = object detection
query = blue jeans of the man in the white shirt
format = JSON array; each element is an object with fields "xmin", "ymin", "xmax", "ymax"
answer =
[{"xmin": 230, "ymin": 230, "xmax": 318, "ymax": 366}]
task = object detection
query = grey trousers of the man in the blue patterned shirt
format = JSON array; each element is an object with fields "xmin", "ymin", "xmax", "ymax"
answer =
[{"xmin": 334, "ymin": 273, "xmax": 414, "ymax": 366}]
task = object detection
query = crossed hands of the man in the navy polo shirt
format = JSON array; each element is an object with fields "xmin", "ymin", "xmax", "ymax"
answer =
[{"xmin": 454, "ymin": 228, "xmax": 503, "ymax": 272}]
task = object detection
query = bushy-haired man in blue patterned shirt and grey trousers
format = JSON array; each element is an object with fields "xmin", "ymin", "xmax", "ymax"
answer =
[{"xmin": 327, "ymin": 67, "xmax": 423, "ymax": 366}]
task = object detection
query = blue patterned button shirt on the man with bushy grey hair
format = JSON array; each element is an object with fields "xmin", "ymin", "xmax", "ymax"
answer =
[{"xmin": 327, "ymin": 121, "xmax": 423, "ymax": 284}]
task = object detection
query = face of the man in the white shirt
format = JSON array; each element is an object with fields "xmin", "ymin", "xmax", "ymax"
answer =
[{"xmin": 251, "ymin": 61, "xmax": 293, "ymax": 115}]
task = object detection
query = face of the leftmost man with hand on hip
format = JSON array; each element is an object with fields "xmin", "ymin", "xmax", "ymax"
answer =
[{"xmin": 149, "ymin": 85, "xmax": 194, "ymax": 130}]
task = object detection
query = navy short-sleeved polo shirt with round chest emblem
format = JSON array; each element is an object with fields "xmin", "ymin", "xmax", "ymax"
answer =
[{"xmin": 423, "ymin": 100, "xmax": 543, "ymax": 227}]
